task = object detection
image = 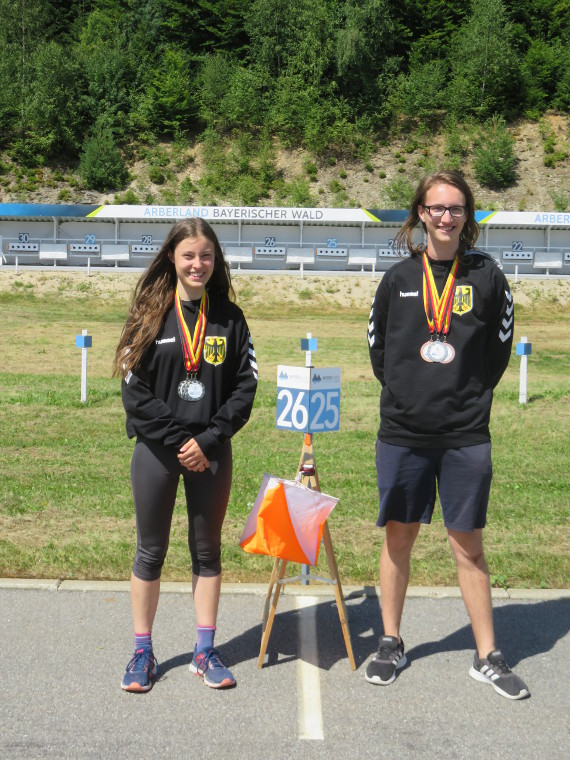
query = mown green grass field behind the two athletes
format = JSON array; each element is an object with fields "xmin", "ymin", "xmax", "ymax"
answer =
[{"xmin": 0, "ymin": 278, "xmax": 570, "ymax": 588}]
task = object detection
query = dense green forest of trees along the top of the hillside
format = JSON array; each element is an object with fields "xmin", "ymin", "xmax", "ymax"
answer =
[{"xmin": 0, "ymin": 0, "xmax": 570, "ymax": 196}]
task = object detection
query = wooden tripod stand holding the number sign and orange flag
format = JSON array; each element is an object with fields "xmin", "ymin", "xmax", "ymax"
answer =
[{"xmin": 257, "ymin": 433, "xmax": 356, "ymax": 670}]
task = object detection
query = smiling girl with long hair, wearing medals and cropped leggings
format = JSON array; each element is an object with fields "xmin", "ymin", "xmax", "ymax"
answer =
[{"xmin": 114, "ymin": 218, "xmax": 257, "ymax": 692}]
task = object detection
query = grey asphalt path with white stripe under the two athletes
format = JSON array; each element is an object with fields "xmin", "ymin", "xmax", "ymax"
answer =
[{"xmin": 0, "ymin": 580, "xmax": 570, "ymax": 760}]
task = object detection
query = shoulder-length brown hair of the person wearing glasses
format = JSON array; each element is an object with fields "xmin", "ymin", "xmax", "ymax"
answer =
[{"xmin": 394, "ymin": 169, "xmax": 479, "ymax": 259}]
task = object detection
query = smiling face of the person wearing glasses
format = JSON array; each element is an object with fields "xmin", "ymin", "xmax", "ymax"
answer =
[{"xmin": 418, "ymin": 184, "xmax": 467, "ymax": 258}]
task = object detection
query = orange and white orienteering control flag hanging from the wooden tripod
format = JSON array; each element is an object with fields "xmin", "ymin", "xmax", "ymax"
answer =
[{"xmin": 236, "ymin": 474, "xmax": 338, "ymax": 565}]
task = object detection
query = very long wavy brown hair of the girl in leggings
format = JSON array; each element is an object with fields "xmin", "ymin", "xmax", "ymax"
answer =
[{"xmin": 113, "ymin": 217, "xmax": 235, "ymax": 377}]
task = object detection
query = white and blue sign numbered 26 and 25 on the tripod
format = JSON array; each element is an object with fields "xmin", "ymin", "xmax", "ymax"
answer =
[{"xmin": 277, "ymin": 366, "xmax": 340, "ymax": 433}]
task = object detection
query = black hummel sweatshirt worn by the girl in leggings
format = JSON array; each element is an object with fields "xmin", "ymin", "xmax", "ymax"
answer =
[{"xmin": 122, "ymin": 296, "xmax": 257, "ymax": 457}]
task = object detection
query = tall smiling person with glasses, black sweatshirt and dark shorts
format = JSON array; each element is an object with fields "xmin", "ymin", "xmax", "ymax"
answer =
[{"xmin": 366, "ymin": 171, "xmax": 529, "ymax": 699}]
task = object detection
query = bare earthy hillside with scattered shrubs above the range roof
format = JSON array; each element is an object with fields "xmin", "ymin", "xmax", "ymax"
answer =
[{"xmin": 0, "ymin": 112, "xmax": 570, "ymax": 211}]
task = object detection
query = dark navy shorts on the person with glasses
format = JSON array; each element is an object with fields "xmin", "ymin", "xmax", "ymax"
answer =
[{"xmin": 376, "ymin": 441, "xmax": 493, "ymax": 531}]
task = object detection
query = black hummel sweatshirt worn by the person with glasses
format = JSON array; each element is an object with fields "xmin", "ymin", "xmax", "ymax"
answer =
[{"xmin": 368, "ymin": 251, "xmax": 514, "ymax": 448}]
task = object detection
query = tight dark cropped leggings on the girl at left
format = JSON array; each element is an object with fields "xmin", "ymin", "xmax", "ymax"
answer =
[{"xmin": 131, "ymin": 439, "xmax": 232, "ymax": 581}]
